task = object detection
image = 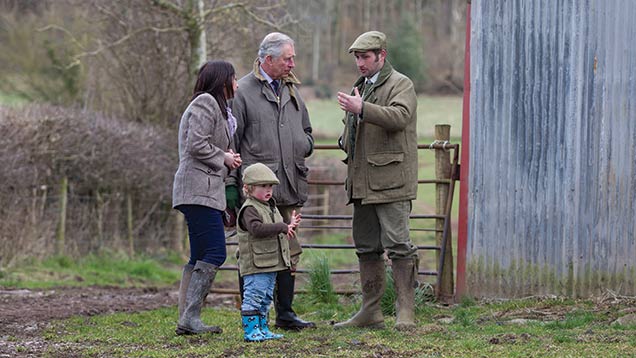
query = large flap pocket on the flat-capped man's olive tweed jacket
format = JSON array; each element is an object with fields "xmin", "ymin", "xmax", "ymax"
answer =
[{"xmin": 367, "ymin": 152, "xmax": 405, "ymax": 190}]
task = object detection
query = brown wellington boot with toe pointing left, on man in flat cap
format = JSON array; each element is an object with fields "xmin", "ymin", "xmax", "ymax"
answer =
[{"xmin": 334, "ymin": 255, "xmax": 386, "ymax": 329}]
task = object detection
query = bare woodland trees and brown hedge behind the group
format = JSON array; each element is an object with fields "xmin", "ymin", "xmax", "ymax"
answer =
[{"xmin": 0, "ymin": 0, "xmax": 466, "ymax": 267}]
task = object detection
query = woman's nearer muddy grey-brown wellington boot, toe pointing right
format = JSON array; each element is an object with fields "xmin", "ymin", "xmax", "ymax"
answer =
[{"xmin": 176, "ymin": 261, "xmax": 223, "ymax": 335}]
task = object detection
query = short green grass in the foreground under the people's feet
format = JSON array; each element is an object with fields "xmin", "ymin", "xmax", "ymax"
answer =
[{"xmin": 41, "ymin": 295, "xmax": 636, "ymax": 357}]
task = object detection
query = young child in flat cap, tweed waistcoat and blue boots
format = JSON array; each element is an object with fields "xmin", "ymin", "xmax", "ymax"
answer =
[{"xmin": 236, "ymin": 163, "xmax": 300, "ymax": 342}]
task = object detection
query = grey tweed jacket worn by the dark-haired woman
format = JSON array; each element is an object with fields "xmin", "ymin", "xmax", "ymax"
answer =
[{"xmin": 172, "ymin": 93, "xmax": 230, "ymax": 210}]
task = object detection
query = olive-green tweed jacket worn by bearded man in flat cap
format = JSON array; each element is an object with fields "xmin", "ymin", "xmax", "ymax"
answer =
[{"xmin": 339, "ymin": 61, "xmax": 417, "ymax": 204}]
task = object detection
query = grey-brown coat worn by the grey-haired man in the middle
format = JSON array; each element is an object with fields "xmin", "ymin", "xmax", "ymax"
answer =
[{"xmin": 232, "ymin": 59, "xmax": 314, "ymax": 206}]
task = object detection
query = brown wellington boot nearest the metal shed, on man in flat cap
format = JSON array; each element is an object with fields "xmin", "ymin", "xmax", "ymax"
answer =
[{"xmin": 392, "ymin": 258, "xmax": 417, "ymax": 331}]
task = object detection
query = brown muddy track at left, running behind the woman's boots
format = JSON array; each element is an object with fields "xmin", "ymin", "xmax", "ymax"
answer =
[{"xmin": 0, "ymin": 287, "xmax": 234, "ymax": 357}]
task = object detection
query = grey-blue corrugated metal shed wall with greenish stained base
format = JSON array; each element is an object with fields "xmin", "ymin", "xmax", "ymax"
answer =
[{"xmin": 466, "ymin": 0, "xmax": 636, "ymax": 297}]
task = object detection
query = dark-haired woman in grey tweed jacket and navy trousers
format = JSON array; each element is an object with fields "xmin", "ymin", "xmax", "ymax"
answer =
[{"xmin": 172, "ymin": 61, "xmax": 241, "ymax": 335}]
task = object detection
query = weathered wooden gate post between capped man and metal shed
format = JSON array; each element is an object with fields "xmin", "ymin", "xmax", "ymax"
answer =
[{"xmin": 435, "ymin": 124, "xmax": 454, "ymax": 302}]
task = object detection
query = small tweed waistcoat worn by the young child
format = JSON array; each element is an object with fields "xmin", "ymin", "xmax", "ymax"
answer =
[{"xmin": 236, "ymin": 198, "xmax": 291, "ymax": 276}]
